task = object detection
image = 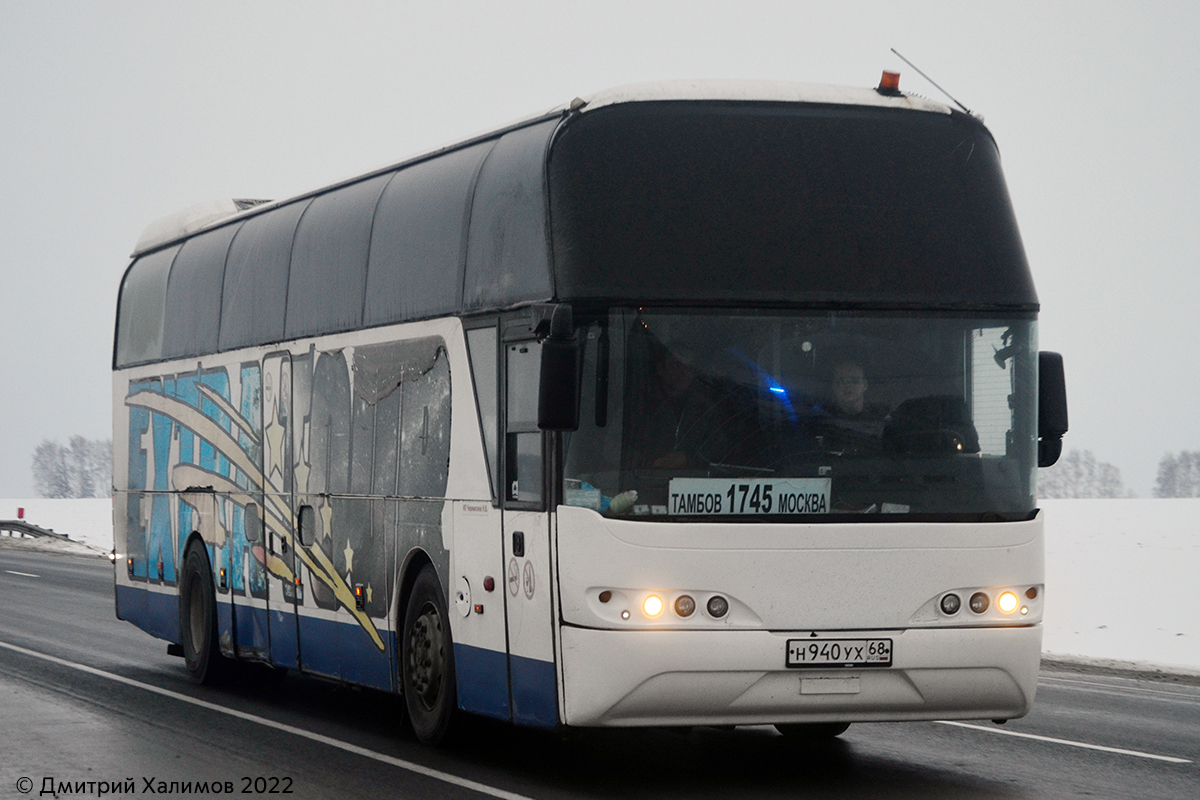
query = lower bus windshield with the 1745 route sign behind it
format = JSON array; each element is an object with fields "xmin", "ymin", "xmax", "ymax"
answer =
[{"xmin": 563, "ymin": 308, "xmax": 1037, "ymax": 521}]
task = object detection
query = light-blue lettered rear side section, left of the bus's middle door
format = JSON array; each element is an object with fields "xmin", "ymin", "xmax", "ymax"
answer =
[{"xmin": 114, "ymin": 363, "xmax": 270, "ymax": 656}]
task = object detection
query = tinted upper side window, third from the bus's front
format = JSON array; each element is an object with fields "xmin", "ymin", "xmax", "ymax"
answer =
[{"xmin": 284, "ymin": 173, "xmax": 392, "ymax": 338}]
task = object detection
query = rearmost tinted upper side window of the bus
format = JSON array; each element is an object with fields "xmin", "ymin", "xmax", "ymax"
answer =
[{"xmin": 116, "ymin": 247, "xmax": 179, "ymax": 367}]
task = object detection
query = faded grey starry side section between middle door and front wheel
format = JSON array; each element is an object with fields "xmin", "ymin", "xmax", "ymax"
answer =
[{"xmin": 292, "ymin": 335, "xmax": 451, "ymax": 688}]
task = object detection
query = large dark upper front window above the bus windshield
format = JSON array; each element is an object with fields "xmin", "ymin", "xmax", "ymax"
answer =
[{"xmin": 548, "ymin": 102, "xmax": 1037, "ymax": 311}]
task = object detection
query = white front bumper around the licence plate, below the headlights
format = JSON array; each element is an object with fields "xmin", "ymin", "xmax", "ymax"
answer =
[{"xmin": 562, "ymin": 625, "xmax": 1042, "ymax": 727}]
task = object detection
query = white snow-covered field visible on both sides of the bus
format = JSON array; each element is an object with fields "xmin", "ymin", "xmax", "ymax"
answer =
[{"xmin": 0, "ymin": 499, "xmax": 1200, "ymax": 670}]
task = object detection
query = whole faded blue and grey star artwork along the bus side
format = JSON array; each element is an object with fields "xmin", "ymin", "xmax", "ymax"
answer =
[{"xmin": 125, "ymin": 339, "xmax": 450, "ymax": 650}]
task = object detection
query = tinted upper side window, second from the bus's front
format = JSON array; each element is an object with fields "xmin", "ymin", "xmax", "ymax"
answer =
[{"xmin": 362, "ymin": 142, "xmax": 493, "ymax": 325}]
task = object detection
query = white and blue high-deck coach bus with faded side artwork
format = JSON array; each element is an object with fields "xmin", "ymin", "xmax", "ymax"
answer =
[{"xmin": 113, "ymin": 76, "xmax": 1067, "ymax": 742}]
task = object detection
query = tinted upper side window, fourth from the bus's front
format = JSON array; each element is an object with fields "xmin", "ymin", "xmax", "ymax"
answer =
[{"xmin": 221, "ymin": 200, "xmax": 308, "ymax": 350}]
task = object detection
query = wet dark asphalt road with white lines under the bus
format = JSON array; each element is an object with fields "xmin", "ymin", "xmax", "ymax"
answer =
[{"xmin": 0, "ymin": 549, "xmax": 1200, "ymax": 800}]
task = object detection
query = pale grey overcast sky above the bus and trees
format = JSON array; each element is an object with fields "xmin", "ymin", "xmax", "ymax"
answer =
[{"xmin": 0, "ymin": 0, "xmax": 1200, "ymax": 498}]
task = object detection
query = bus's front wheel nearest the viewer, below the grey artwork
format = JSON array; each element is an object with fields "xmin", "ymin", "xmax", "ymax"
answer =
[{"xmin": 400, "ymin": 564, "xmax": 457, "ymax": 745}]
